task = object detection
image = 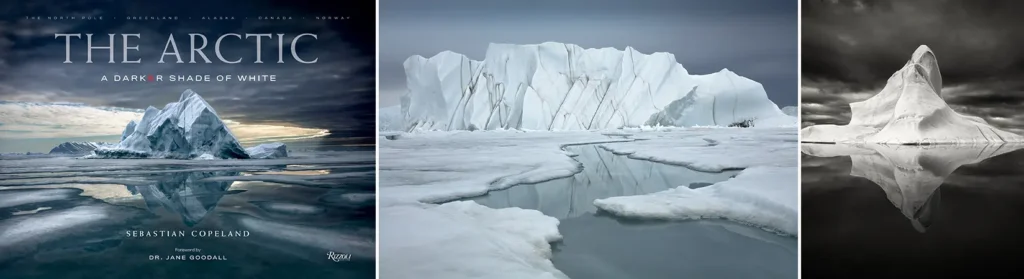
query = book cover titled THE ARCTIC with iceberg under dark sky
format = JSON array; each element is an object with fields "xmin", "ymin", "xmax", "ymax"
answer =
[{"xmin": 0, "ymin": 0, "xmax": 376, "ymax": 278}]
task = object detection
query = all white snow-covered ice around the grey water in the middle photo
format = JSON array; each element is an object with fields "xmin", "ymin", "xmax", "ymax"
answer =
[{"xmin": 378, "ymin": 127, "xmax": 799, "ymax": 279}]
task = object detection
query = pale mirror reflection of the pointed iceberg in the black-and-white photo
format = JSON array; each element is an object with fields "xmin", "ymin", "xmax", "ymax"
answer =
[{"xmin": 801, "ymin": 144, "xmax": 1024, "ymax": 233}]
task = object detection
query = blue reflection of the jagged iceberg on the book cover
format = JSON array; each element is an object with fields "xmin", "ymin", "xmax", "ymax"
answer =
[{"xmin": 128, "ymin": 171, "xmax": 240, "ymax": 227}]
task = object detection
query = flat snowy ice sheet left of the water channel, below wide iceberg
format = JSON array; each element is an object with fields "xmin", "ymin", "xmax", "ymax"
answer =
[{"xmin": 378, "ymin": 130, "xmax": 631, "ymax": 207}]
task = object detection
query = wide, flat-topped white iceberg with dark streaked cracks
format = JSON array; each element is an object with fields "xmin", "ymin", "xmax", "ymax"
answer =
[{"xmin": 393, "ymin": 42, "xmax": 797, "ymax": 130}]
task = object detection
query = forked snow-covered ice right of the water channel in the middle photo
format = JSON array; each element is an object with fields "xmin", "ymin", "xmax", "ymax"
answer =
[{"xmin": 594, "ymin": 128, "xmax": 799, "ymax": 235}]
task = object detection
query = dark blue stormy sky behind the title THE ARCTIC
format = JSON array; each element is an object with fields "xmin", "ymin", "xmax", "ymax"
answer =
[{"xmin": 0, "ymin": 0, "xmax": 376, "ymax": 143}]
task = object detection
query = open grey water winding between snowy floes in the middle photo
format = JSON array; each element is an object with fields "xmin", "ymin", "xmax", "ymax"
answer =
[{"xmin": 469, "ymin": 145, "xmax": 797, "ymax": 279}]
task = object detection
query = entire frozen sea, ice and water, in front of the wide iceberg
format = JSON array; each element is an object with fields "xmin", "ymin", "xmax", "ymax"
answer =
[{"xmin": 379, "ymin": 128, "xmax": 798, "ymax": 279}]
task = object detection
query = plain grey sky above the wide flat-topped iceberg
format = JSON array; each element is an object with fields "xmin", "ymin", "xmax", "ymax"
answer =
[{"xmin": 380, "ymin": 0, "xmax": 798, "ymax": 107}]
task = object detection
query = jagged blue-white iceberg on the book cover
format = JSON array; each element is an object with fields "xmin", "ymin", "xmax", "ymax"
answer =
[{"xmin": 90, "ymin": 89, "xmax": 287, "ymax": 159}]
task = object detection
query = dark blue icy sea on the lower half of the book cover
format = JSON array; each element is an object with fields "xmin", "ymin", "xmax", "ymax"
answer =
[{"xmin": 0, "ymin": 140, "xmax": 376, "ymax": 279}]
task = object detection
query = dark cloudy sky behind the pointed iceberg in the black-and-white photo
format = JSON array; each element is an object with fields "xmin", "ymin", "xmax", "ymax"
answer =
[{"xmin": 801, "ymin": 0, "xmax": 1024, "ymax": 133}]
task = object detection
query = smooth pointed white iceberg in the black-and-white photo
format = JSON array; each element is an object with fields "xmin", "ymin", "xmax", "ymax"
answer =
[{"xmin": 800, "ymin": 45, "xmax": 1024, "ymax": 145}]
